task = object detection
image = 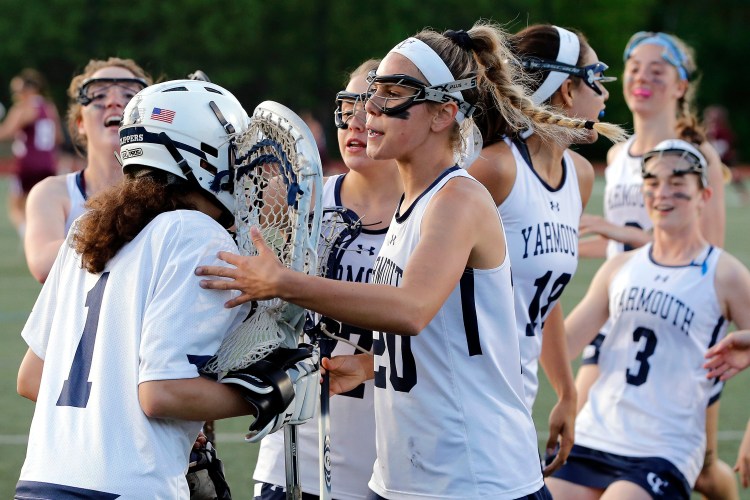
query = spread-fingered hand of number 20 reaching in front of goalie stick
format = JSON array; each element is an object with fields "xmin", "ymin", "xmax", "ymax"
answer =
[{"xmin": 195, "ymin": 227, "xmax": 286, "ymax": 307}]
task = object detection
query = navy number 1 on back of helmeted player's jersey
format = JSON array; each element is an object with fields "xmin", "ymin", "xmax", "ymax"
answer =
[{"xmin": 57, "ymin": 273, "xmax": 109, "ymax": 408}]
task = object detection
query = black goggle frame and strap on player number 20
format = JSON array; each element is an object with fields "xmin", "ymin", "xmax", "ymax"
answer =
[{"xmin": 367, "ymin": 70, "xmax": 477, "ymax": 118}]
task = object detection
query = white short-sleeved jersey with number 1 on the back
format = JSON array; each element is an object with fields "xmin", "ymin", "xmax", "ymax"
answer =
[{"xmin": 18, "ymin": 210, "xmax": 247, "ymax": 500}]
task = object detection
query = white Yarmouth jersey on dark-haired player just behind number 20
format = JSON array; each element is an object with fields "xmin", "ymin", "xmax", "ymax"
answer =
[{"xmin": 498, "ymin": 139, "xmax": 583, "ymax": 409}]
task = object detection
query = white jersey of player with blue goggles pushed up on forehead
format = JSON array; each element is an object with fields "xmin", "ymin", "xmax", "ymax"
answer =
[{"xmin": 604, "ymin": 135, "xmax": 653, "ymax": 259}]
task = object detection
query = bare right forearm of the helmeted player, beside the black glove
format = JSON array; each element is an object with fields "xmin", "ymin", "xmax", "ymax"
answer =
[{"xmin": 138, "ymin": 377, "xmax": 254, "ymax": 421}]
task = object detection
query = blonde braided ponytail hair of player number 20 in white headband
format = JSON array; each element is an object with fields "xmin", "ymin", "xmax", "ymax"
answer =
[{"xmin": 415, "ymin": 21, "xmax": 625, "ymax": 149}]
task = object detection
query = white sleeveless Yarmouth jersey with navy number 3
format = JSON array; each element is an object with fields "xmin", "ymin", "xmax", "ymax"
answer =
[{"xmin": 576, "ymin": 244, "xmax": 727, "ymax": 486}]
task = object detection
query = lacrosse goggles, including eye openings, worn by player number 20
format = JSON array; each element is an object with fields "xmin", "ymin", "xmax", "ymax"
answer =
[{"xmin": 367, "ymin": 71, "xmax": 477, "ymax": 118}]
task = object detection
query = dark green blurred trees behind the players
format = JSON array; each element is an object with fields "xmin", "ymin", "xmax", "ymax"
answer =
[{"xmin": 0, "ymin": 0, "xmax": 750, "ymax": 161}]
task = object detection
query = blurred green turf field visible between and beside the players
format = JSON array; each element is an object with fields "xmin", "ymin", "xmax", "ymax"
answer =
[{"xmin": 0, "ymin": 177, "xmax": 750, "ymax": 500}]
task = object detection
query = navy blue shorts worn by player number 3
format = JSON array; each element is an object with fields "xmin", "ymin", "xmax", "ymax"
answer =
[{"xmin": 552, "ymin": 444, "xmax": 691, "ymax": 500}]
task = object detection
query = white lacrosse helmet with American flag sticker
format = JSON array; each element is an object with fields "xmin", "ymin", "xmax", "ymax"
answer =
[{"xmin": 120, "ymin": 80, "xmax": 250, "ymax": 221}]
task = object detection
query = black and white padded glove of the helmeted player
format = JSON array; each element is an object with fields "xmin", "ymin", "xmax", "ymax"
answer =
[{"xmin": 220, "ymin": 344, "xmax": 320, "ymax": 443}]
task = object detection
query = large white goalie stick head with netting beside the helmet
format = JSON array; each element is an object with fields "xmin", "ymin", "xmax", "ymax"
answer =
[{"xmin": 204, "ymin": 101, "xmax": 322, "ymax": 373}]
